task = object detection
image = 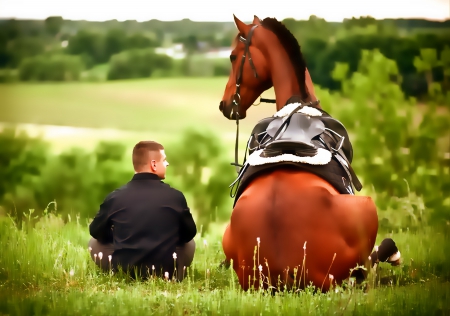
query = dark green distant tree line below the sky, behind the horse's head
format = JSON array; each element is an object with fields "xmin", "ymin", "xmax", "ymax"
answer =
[{"xmin": 0, "ymin": 16, "xmax": 450, "ymax": 98}]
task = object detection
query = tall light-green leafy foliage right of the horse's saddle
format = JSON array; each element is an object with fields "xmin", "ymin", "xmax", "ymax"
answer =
[{"xmin": 333, "ymin": 50, "xmax": 450, "ymax": 227}]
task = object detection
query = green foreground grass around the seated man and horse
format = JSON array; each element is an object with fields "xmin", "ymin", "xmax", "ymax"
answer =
[{"xmin": 0, "ymin": 216, "xmax": 450, "ymax": 315}]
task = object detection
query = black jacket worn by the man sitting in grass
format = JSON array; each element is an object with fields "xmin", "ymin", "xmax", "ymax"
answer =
[{"xmin": 89, "ymin": 173, "xmax": 197, "ymax": 275}]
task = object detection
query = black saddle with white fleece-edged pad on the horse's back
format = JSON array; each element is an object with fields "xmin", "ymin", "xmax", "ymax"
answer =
[{"xmin": 230, "ymin": 103, "xmax": 362, "ymax": 201}]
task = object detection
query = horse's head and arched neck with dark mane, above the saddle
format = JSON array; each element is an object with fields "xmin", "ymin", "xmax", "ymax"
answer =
[{"xmin": 219, "ymin": 16, "xmax": 316, "ymax": 120}]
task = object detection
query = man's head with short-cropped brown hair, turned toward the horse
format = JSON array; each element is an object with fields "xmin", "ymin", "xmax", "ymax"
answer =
[{"xmin": 133, "ymin": 141, "xmax": 169, "ymax": 179}]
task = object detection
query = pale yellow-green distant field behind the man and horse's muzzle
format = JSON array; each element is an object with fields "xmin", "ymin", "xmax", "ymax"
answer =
[{"xmin": 0, "ymin": 77, "xmax": 275, "ymax": 152}]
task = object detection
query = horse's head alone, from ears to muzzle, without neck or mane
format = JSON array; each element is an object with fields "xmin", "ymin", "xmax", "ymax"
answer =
[{"xmin": 219, "ymin": 16, "xmax": 272, "ymax": 120}]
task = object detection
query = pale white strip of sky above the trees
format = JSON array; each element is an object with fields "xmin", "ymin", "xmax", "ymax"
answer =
[{"xmin": 0, "ymin": 0, "xmax": 450, "ymax": 22}]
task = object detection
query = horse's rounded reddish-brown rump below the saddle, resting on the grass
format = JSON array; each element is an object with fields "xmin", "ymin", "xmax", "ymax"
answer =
[{"xmin": 223, "ymin": 169, "xmax": 378, "ymax": 288}]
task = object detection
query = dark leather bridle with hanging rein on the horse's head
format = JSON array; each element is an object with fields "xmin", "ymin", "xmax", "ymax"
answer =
[{"xmin": 230, "ymin": 25, "xmax": 276, "ymax": 173}]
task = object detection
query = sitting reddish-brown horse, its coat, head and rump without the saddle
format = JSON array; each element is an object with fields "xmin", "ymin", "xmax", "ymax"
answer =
[{"xmin": 219, "ymin": 16, "xmax": 398, "ymax": 291}]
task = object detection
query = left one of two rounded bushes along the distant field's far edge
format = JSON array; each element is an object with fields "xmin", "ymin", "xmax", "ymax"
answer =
[{"xmin": 19, "ymin": 55, "xmax": 84, "ymax": 81}]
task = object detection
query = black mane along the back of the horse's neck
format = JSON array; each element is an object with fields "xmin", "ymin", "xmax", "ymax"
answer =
[{"xmin": 261, "ymin": 18, "xmax": 308, "ymax": 99}]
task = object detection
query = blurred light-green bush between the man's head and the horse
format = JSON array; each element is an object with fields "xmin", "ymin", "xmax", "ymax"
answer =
[{"xmin": 166, "ymin": 130, "xmax": 235, "ymax": 232}]
